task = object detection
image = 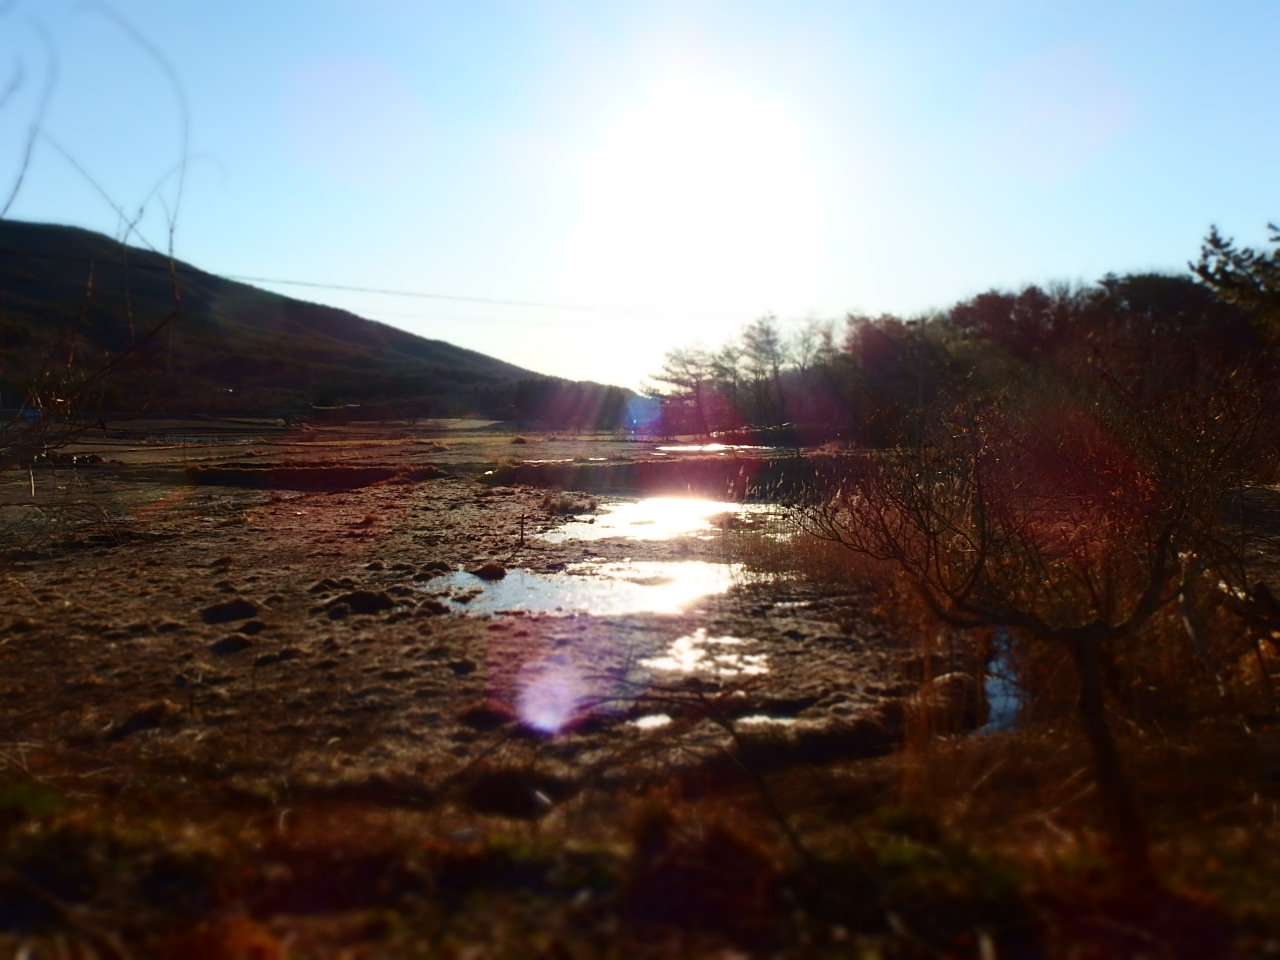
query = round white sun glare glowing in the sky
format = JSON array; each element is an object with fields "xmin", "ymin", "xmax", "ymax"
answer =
[{"xmin": 564, "ymin": 72, "xmax": 822, "ymax": 320}]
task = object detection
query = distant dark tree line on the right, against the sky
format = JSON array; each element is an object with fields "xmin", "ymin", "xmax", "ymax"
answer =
[{"xmin": 653, "ymin": 228, "xmax": 1280, "ymax": 447}]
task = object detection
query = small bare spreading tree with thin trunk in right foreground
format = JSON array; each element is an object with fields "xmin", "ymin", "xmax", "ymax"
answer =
[{"xmin": 794, "ymin": 358, "xmax": 1265, "ymax": 879}]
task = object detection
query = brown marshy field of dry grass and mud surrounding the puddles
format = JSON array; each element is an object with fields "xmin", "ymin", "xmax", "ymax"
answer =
[{"xmin": 0, "ymin": 421, "xmax": 1280, "ymax": 960}]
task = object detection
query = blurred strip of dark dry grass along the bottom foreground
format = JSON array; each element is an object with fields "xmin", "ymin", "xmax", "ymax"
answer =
[{"xmin": 0, "ymin": 696, "xmax": 1280, "ymax": 957}]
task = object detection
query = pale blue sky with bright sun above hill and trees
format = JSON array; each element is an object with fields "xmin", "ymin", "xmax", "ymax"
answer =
[{"xmin": 0, "ymin": 0, "xmax": 1280, "ymax": 387}]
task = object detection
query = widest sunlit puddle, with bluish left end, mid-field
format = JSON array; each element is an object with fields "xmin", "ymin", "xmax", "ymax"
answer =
[{"xmin": 424, "ymin": 561, "xmax": 742, "ymax": 617}]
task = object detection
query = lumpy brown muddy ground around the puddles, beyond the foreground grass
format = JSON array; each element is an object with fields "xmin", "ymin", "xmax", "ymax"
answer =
[{"xmin": 0, "ymin": 424, "xmax": 942, "ymax": 817}]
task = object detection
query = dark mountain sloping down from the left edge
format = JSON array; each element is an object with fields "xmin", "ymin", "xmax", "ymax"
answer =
[{"xmin": 0, "ymin": 220, "xmax": 545, "ymax": 416}]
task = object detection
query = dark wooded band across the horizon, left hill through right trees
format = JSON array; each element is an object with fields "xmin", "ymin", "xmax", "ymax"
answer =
[{"xmin": 0, "ymin": 220, "xmax": 1280, "ymax": 447}]
